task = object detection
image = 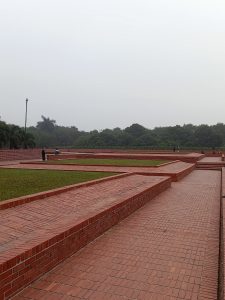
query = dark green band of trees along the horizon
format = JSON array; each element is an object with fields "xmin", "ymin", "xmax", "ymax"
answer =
[{"xmin": 0, "ymin": 116, "xmax": 225, "ymax": 149}]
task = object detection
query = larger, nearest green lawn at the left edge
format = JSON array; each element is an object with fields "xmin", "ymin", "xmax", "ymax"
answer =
[{"xmin": 0, "ymin": 169, "xmax": 116, "ymax": 201}]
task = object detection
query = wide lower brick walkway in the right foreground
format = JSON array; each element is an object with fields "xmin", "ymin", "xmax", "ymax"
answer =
[{"xmin": 11, "ymin": 170, "xmax": 220, "ymax": 300}]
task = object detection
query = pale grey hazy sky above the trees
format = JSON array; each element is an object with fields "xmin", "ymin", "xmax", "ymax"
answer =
[{"xmin": 0, "ymin": 0, "xmax": 225, "ymax": 130}]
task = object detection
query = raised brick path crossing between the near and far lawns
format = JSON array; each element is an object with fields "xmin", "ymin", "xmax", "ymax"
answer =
[{"xmin": 4, "ymin": 162, "xmax": 195, "ymax": 181}]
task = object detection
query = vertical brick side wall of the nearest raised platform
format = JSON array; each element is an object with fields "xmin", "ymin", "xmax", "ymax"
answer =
[{"xmin": 0, "ymin": 177, "xmax": 171, "ymax": 299}]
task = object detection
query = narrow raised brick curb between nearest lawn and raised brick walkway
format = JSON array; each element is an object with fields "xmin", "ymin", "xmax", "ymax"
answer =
[{"xmin": 0, "ymin": 172, "xmax": 130, "ymax": 210}]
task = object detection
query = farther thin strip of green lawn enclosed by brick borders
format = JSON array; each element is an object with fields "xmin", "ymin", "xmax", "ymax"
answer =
[{"xmin": 48, "ymin": 158, "xmax": 169, "ymax": 167}]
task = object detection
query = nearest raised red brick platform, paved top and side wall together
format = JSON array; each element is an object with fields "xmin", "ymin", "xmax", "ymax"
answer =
[{"xmin": 0, "ymin": 175, "xmax": 171, "ymax": 299}]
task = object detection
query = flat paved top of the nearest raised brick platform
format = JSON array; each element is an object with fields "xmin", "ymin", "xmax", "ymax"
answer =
[{"xmin": 0, "ymin": 175, "xmax": 163, "ymax": 262}]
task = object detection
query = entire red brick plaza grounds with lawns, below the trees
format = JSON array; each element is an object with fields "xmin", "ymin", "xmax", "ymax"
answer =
[{"xmin": 0, "ymin": 150, "xmax": 225, "ymax": 300}]
